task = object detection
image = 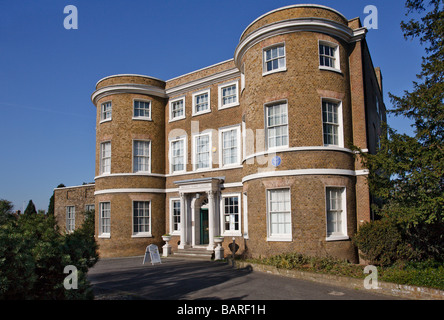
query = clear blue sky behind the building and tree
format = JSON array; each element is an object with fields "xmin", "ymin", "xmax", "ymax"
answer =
[{"xmin": 0, "ymin": 0, "xmax": 424, "ymax": 210}]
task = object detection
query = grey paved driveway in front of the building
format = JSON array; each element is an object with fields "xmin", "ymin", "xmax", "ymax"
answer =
[{"xmin": 88, "ymin": 257, "xmax": 394, "ymax": 300}]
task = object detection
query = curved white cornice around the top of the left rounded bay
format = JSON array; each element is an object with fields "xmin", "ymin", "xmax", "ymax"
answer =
[{"xmin": 91, "ymin": 83, "xmax": 168, "ymax": 105}]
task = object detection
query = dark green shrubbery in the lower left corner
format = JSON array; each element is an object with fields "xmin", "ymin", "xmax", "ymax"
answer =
[{"xmin": 0, "ymin": 201, "xmax": 98, "ymax": 300}]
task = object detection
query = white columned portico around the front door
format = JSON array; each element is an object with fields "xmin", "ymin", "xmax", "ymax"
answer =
[{"xmin": 174, "ymin": 177, "xmax": 225, "ymax": 251}]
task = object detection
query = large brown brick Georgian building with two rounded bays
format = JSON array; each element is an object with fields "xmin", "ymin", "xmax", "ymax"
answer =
[{"xmin": 55, "ymin": 5, "xmax": 386, "ymax": 262}]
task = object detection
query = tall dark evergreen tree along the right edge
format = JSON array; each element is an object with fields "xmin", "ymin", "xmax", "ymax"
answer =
[{"xmin": 361, "ymin": 0, "xmax": 444, "ymax": 260}]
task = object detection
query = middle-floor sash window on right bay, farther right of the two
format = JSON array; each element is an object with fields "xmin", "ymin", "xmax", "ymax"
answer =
[{"xmin": 322, "ymin": 100, "xmax": 344, "ymax": 147}]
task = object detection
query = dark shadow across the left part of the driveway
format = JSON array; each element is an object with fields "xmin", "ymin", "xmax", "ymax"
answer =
[{"xmin": 88, "ymin": 257, "xmax": 251, "ymax": 300}]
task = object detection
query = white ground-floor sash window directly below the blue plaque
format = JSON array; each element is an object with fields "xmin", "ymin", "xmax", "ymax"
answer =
[{"xmin": 267, "ymin": 189, "xmax": 291, "ymax": 241}]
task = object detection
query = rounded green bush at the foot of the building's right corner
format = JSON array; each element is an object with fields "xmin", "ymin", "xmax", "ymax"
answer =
[{"xmin": 353, "ymin": 219, "xmax": 415, "ymax": 266}]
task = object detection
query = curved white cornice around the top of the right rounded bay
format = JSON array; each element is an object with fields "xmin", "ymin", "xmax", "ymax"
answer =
[{"xmin": 234, "ymin": 18, "xmax": 367, "ymax": 68}]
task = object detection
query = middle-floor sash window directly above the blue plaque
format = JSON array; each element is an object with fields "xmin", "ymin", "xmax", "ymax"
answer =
[{"xmin": 265, "ymin": 102, "xmax": 288, "ymax": 149}]
